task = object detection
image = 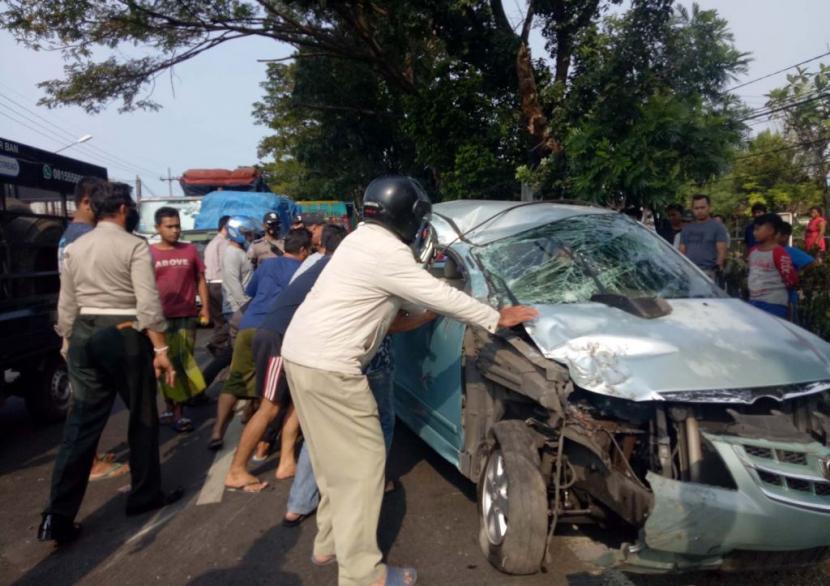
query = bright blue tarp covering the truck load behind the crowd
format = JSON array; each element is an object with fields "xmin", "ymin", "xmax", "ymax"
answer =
[{"xmin": 194, "ymin": 191, "xmax": 300, "ymax": 234}]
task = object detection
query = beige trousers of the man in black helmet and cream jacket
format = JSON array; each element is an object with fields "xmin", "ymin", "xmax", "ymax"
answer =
[{"xmin": 285, "ymin": 360, "xmax": 386, "ymax": 586}]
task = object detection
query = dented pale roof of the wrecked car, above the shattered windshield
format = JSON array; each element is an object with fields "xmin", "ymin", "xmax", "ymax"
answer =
[{"xmin": 432, "ymin": 199, "xmax": 615, "ymax": 245}]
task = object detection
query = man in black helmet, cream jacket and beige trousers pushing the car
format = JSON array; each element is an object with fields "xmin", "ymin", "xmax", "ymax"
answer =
[{"xmin": 283, "ymin": 176, "xmax": 537, "ymax": 586}]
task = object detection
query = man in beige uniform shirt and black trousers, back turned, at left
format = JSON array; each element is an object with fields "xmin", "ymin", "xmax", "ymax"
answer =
[{"xmin": 38, "ymin": 184, "xmax": 182, "ymax": 544}]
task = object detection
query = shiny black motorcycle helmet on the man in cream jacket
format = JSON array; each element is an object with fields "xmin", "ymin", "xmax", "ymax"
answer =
[{"xmin": 363, "ymin": 175, "xmax": 432, "ymax": 244}]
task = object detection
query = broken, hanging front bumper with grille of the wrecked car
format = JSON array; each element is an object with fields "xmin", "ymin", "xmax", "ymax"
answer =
[{"xmin": 619, "ymin": 433, "xmax": 830, "ymax": 572}]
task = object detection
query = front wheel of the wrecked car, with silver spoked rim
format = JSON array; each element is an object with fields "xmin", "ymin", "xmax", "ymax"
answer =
[{"xmin": 478, "ymin": 421, "xmax": 548, "ymax": 574}]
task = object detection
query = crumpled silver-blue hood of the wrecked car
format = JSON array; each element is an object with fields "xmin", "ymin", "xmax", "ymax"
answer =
[{"xmin": 526, "ymin": 299, "xmax": 830, "ymax": 403}]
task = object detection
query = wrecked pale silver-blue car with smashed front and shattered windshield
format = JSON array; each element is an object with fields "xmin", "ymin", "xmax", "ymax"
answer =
[{"xmin": 394, "ymin": 201, "xmax": 830, "ymax": 574}]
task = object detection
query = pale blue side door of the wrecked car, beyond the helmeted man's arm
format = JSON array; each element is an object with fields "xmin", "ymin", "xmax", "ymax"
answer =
[{"xmin": 392, "ymin": 252, "xmax": 466, "ymax": 466}]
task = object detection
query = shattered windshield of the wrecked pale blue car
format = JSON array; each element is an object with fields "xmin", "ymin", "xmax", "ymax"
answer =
[{"xmin": 475, "ymin": 214, "xmax": 722, "ymax": 304}]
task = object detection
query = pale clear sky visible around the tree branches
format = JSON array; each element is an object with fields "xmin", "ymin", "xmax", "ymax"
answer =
[{"xmin": 0, "ymin": 0, "xmax": 830, "ymax": 195}]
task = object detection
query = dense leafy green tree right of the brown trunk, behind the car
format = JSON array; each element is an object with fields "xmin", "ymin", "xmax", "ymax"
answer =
[{"xmin": 537, "ymin": 1, "xmax": 746, "ymax": 207}]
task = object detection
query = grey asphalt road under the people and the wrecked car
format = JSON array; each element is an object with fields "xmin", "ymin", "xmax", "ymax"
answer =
[{"xmin": 0, "ymin": 336, "xmax": 830, "ymax": 586}]
